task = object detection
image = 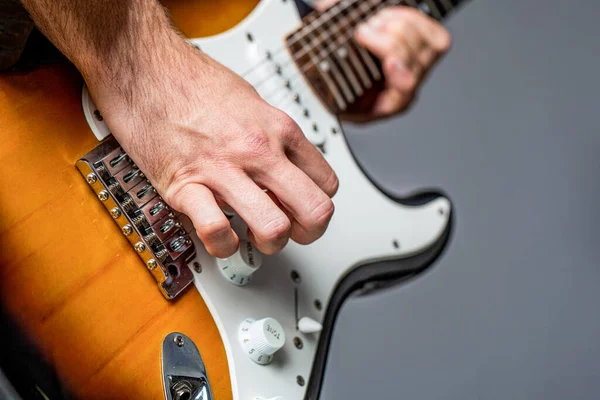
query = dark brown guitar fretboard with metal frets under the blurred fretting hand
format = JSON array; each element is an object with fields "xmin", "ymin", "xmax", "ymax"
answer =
[{"xmin": 286, "ymin": 0, "xmax": 464, "ymax": 114}]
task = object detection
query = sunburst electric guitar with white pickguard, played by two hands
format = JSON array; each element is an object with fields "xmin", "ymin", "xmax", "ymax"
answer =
[{"xmin": 0, "ymin": 0, "xmax": 459, "ymax": 400}]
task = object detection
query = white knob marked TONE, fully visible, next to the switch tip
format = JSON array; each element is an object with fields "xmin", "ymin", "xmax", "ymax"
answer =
[{"xmin": 240, "ymin": 318, "xmax": 285, "ymax": 364}]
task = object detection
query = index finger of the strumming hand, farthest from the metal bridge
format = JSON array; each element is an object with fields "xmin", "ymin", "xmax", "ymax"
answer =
[{"xmin": 286, "ymin": 132, "xmax": 339, "ymax": 197}]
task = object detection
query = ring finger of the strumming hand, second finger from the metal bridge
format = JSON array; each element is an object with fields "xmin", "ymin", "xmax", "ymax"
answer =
[{"xmin": 218, "ymin": 172, "xmax": 291, "ymax": 254}]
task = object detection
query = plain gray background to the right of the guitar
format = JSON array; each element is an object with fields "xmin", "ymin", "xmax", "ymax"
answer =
[{"xmin": 322, "ymin": 0, "xmax": 600, "ymax": 400}]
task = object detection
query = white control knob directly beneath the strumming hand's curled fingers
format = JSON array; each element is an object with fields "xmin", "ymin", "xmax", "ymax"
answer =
[{"xmin": 217, "ymin": 240, "xmax": 262, "ymax": 286}]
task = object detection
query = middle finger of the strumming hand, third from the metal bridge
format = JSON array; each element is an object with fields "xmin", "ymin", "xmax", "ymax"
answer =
[{"xmin": 257, "ymin": 161, "xmax": 334, "ymax": 244}]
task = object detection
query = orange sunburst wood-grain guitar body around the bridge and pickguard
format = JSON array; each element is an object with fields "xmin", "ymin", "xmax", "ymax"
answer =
[{"xmin": 0, "ymin": 0, "xmax": 257, "ymax": 400}]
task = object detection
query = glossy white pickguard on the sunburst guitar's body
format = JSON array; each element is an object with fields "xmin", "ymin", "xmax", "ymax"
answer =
[{"xmin": 83, "ymin": 0, "xmax": 451, "ymax": 400}]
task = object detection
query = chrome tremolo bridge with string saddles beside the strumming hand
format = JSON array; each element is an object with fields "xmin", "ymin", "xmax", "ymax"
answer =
[{"xmin": 77, "ymin": 137, "xmax": 196, "ymax": 299}]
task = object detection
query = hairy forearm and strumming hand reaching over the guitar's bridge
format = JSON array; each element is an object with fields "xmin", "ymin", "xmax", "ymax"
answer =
[{"xmin": 23, "ymin": 0, "xmax": 338, "ymax": 257}]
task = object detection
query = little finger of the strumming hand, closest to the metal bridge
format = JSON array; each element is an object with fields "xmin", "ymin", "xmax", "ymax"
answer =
[{"xmin": 172, "ymin": 184, "xmax": 239, "ymax": 258}]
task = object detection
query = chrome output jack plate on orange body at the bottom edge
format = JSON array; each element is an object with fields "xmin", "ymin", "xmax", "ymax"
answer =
[{"xmin": 162, "ymin": 332, "xmax": 213, "ymax": 400}]
